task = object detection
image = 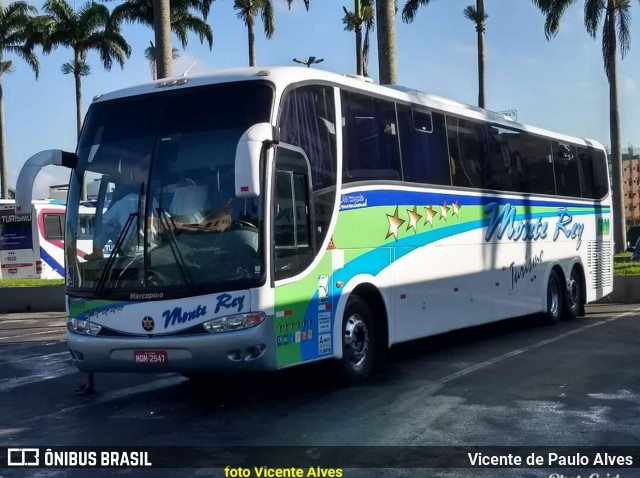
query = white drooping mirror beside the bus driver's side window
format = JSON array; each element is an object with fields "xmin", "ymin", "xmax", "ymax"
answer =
[{"xmin": 235, "ymin": 123, "xmax": 276, "ymax": 198}]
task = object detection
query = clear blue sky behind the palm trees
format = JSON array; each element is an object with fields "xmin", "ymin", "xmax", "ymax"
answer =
[{"xmin": 3, "ymin": 0, "xmax": 640, "ymax": 196}]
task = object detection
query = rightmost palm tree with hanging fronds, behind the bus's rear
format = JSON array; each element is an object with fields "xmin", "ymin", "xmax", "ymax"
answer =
[{"xmin": 533, "ymin": 0, "xmax": 631, "ymax": 252}]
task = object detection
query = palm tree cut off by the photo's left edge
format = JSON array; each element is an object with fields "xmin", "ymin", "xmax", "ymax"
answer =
[{"xmin": 0, "ymin": 2, "xmax": 39, "ymax": 199}]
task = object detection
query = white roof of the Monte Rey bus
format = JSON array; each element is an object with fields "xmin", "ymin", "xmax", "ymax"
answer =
[{"xmin": 94, "ymin": 66, "xmax": 605, "ymax": 150}]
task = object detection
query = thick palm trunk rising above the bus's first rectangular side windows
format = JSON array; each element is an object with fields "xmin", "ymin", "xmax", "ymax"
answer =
[{"xmin": 376, "ymin": 0, "xmax": 398, "ymax": 85}]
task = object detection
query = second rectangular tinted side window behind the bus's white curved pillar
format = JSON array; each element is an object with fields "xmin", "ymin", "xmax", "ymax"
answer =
[{"xmin": 397, "ymin": 105, "xmax": 451, "ymax": 184}]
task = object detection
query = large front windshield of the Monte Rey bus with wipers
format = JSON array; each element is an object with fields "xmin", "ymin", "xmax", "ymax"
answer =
[{"xmin": 65, "ymin": 82, "xmax": 273, "ymax": 297}]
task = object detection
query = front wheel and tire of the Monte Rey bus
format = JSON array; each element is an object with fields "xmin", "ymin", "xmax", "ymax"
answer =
[{"xmin": 340, "ymin": 295, "xmax": 377, "ymax": 385}]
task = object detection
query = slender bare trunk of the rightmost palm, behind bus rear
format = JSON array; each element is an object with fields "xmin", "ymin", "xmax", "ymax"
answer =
[{"xmin": 605, "ymin": 0, "xmax": 627, "ymax": 253}]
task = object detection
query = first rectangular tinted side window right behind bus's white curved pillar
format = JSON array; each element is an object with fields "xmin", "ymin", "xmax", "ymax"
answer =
[{"xmin": 341, "ymin": 91, "xmax": 402, "ymax": 182}]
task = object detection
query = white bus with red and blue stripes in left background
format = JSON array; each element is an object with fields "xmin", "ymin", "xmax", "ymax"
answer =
[{"xmin": 0, "ymin": 199, "xmax": 95, "ymax": 279}]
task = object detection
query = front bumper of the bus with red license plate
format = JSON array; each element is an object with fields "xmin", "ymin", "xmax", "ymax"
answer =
[{"xmin": 67, "ymin": 323, "xmax": 277, "ymax": 373}]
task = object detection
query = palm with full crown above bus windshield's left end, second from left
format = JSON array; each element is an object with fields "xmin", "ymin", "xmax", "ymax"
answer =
[{"xmin": 41, "ymin": 0, "xmax": 131, "ymax": 135}]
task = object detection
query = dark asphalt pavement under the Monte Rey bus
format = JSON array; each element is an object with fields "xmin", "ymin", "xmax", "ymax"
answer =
[{"xmin": 0, "ymin": 304, "xmax": 640, "ymax": 478}]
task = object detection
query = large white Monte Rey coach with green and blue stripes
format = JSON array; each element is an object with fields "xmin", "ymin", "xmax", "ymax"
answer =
[{"xmin": 18, "ymin": 67, "xmax": 613, "ymax": 381}]
